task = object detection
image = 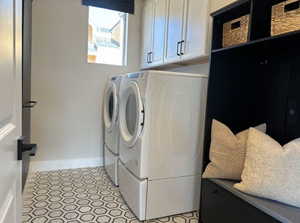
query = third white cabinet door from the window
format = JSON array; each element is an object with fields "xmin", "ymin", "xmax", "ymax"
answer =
[{"xmin": 165, "ymin": 0, "xmax": 186, "ymax": 63}]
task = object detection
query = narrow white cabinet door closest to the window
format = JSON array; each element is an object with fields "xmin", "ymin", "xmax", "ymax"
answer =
[{"xmin": 142, "ymin": 0, "xmax": 155, "ymax": 68}]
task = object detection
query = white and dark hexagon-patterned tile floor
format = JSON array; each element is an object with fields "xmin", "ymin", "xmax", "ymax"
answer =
[{"xmin": 23, "ymin": 167, "xmax": 198, "ymax": 223}]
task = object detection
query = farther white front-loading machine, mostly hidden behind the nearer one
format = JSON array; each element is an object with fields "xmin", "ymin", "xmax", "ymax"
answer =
[{"xmin": 103, "ymin": 76, "xmax": 122, "ymax": 185}]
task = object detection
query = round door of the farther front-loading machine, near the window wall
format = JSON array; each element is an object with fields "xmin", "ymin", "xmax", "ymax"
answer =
[{"xmin": 104, "ymin": 82, "xmax": 118, "ymax": 131}]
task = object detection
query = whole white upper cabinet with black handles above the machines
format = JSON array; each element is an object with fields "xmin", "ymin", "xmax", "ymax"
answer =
[{"xmin": 142, "ymin": 0, "xmax": 220, "ymax": 68}]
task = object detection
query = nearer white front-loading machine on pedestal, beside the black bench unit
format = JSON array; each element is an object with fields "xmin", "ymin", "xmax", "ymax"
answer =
[{"xmin": 119, "ymin": 71, "xmax": 208, "ymax": 220}]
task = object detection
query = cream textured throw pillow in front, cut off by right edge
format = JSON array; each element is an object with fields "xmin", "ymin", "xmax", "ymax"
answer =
[{"xmin": 234, "ymin": 128, "xmax": 300, "ymax": 207}]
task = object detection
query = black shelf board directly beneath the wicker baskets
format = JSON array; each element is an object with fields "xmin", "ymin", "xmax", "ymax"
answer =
[{"xmin": 212, "ymin": 30, "xmax": 300, "ymax": 54}]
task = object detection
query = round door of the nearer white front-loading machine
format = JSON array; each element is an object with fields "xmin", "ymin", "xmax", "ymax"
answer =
[{"xmin": 120, "ymin": 81, "xmax": 144, "ymax": 147}]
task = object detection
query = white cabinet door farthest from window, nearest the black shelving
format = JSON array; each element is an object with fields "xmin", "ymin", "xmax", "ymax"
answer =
[{"xmin": 181, "ymin": 0, "xmax": 210, "ymax": 60}]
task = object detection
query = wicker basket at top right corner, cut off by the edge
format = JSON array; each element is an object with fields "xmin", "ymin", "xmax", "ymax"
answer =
[{"xmin": 271, "ymin": 0, "xmax": 300, "ymax": 36}]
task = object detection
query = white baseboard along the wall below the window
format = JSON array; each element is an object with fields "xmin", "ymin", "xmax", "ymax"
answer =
[{"xmin": 29, "ymin": 157, "xmax": 103, "ymax": 172}]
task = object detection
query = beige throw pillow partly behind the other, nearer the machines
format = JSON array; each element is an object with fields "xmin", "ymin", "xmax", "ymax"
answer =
[{"xmin": 203, "ymin": 120, "xmax": 267, "ymax": 180}]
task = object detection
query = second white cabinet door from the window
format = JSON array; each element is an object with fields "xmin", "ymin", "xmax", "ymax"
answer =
[{"xmin": 151, "ymin": 0, "xmax": 167, "ymax": 66}]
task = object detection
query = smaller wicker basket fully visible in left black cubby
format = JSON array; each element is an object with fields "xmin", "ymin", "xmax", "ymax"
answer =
[{"xmin": 223, "ymin": 15, "xmax": 250, "ymax": 47}]
